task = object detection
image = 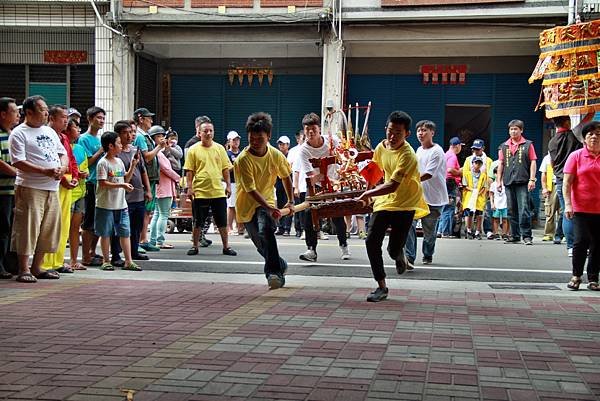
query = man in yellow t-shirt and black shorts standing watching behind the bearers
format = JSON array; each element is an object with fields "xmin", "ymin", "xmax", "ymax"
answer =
[{"xmin": 183, "ymin": 117, "xmax": 237, "ymax": 256}]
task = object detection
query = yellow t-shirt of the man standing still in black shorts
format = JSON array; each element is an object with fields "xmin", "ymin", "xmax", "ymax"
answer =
[{"xmin": 183, "ymin": 142, "xmax": 232, "ymax": 199}]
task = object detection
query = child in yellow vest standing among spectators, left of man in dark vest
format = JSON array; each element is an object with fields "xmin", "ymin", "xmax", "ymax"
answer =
[{"xmin": 463, "ymin": 156, "xmax": 488, "ymax": 240}]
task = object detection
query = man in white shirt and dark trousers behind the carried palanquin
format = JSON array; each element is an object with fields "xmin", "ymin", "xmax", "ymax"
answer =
[{"xmin": 292, "ymin": 113, "xmax": 350, "ymax": 262}]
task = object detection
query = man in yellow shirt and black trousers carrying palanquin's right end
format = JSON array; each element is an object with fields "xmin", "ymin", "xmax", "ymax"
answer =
[{"xmin": 358, "ymin": 111, "xmax": 429, "ymax": 302}]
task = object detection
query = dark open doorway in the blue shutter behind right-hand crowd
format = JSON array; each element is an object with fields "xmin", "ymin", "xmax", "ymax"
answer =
[{"xmin": 444, "ymin": 104, "xmax": 492, "ymax": 166}]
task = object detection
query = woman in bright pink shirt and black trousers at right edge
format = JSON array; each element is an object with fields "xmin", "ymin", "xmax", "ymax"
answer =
[{"xmin": 562, "ymin": 121, "xmax": 600, "ymax": 291}]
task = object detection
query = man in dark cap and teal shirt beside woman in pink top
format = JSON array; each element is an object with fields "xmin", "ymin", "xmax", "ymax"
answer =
[{"xmin": 133, "ymin": 107, "xmax": 167, "ymax": 252}]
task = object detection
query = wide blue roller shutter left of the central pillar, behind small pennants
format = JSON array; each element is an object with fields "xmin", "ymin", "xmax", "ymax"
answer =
[{"xmin": 171, "ymin": 75, "xmax": 321, "ymax": 146}]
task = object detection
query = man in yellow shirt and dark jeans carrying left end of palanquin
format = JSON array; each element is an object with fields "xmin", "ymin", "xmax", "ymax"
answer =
[{"xmin": 233, "ymin": 112, "xmax": 294, "ymax": 290}]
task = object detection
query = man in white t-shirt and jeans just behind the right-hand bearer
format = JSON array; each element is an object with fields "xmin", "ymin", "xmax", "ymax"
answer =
[{"xmin": 405, "ymin": 120, "xmax": 448, "ymax": 265}]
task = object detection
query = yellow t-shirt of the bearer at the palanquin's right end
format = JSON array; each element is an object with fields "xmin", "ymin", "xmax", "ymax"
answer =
[{"xmin": 373, "ymin": 140, "xmax": 429, "ymax": 219}]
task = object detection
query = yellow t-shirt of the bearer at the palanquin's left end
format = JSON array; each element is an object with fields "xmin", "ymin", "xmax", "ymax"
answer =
[{"xmin": 233, "ymin": 145, "xmax": 292, "ymax": 223}]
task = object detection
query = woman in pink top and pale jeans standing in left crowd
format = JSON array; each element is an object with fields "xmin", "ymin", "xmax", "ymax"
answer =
[{"xmin": 150, "ymin": 130, "xmax": 181, "ymax": 249}]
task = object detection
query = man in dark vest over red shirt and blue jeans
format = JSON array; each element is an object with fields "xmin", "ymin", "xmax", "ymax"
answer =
[{"xmin": 496, "ymin": 120, "xmax": 537, "ymax": 245}]
